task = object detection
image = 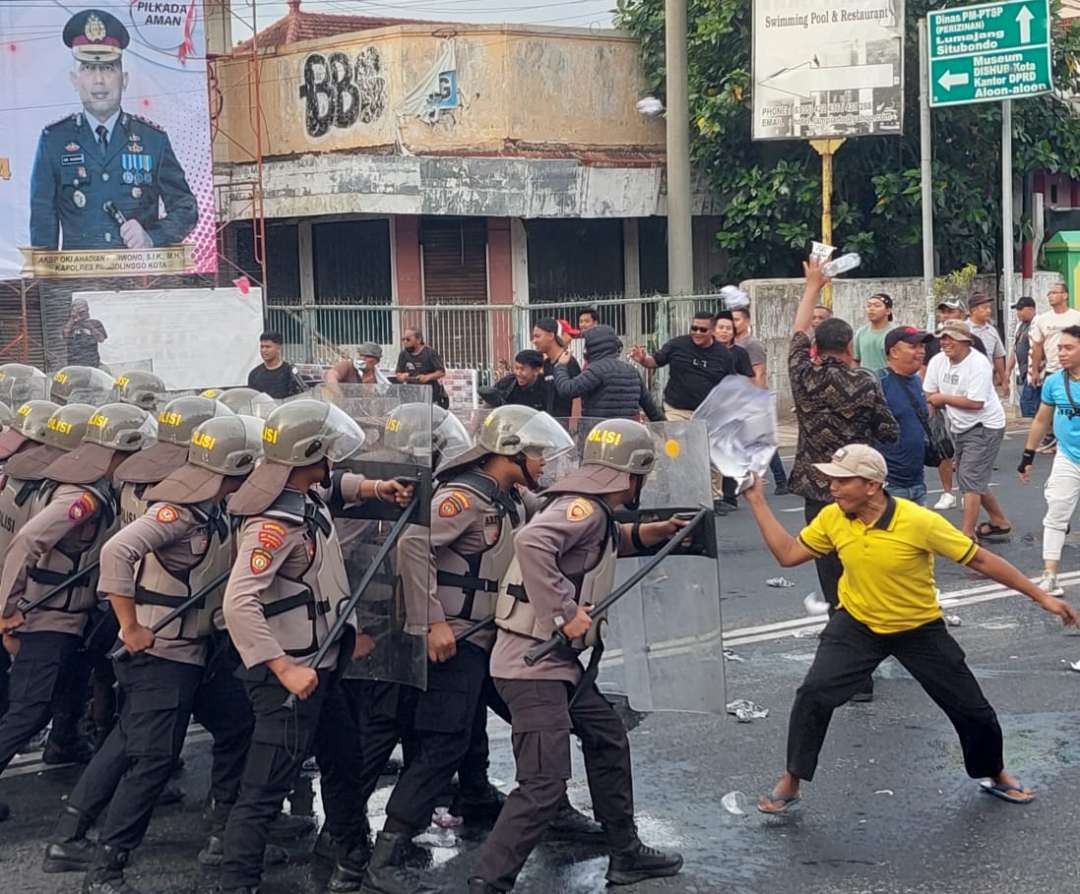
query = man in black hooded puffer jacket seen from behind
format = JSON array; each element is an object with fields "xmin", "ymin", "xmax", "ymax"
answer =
[{"xmin": 554, "ymin": 326, "xmax": 664, "ymax": 422}]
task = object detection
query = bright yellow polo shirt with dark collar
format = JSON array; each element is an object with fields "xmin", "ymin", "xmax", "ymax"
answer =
[{"xmin": 799, "ymin": 497, "xmax": 978, "ymax": 634}]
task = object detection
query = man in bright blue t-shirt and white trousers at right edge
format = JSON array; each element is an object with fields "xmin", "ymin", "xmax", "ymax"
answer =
[{"xmin": 1016, "ymin": 326, "xmax": 1080, "ymax": 596}]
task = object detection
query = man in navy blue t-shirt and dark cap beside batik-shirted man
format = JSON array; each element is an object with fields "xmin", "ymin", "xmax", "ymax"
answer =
[{"xmin": 874, "ymin": 326, "xmax": 932, "ymax": 505}]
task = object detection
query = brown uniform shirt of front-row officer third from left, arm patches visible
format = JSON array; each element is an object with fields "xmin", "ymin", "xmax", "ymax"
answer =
[{"xmin": 222, "ymin": 473, "xmax": 364, "ymax": 669}]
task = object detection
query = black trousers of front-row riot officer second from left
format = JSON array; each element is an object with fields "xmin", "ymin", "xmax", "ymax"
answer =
[{"xmin": 68, "ymin": 634, "xmax": 255, "ymax": 833}]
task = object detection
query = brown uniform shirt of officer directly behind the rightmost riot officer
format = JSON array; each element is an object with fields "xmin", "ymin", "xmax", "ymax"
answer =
[{"xmin": 399, "ymin": 484, "xmax": 502, "ymax": 649}]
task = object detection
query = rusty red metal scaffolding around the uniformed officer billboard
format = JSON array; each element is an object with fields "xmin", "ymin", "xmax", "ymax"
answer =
[{"xmin": 0, "ymin": 0, "xmax": 267, "ymax": 368}]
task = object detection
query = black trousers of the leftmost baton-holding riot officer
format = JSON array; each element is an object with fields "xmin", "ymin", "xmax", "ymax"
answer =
[{"xmin": 0, "ymin": 632, "xmax": 82, "ymax": 772}]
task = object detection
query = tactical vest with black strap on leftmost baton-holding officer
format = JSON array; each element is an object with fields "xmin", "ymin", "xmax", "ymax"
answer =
[{"xmin": 23, "ymin": 478, "xmax": 118, "ymax": 614}]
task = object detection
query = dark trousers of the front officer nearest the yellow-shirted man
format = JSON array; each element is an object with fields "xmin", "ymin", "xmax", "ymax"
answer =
[{"xmin": 475, "ymin": 679, "xmax": 635, "ymax": 891}]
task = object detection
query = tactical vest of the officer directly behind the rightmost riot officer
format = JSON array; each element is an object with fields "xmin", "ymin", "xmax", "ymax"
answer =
[{"xmin": 435, "ymin": 472, "xmax": 525, "ymax": 621}]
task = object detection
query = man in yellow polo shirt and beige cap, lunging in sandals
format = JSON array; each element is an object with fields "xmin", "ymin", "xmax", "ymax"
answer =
[{"xmin": 745, "ymin": 444, "xmax": 1080, "ymax": 813}]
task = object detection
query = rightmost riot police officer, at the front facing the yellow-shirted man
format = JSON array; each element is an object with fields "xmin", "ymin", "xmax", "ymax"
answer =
[{"xmin": 469, "ymin": 419, "xmax": 685, "ymax": 894}]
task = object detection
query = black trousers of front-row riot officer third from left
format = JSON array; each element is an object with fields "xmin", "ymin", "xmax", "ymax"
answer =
[{"xmin": 221, "ymin": 665, "xmax": 332, "ymax": 889}]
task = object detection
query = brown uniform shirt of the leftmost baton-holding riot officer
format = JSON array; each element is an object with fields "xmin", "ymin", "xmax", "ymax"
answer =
[{"xmin": 0, "ymin": 485, "xmax": 102, "ymax": 636}]
